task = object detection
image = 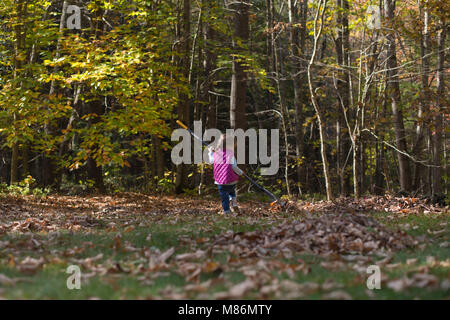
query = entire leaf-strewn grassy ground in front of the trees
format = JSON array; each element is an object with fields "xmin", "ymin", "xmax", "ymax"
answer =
[{"xmin": 0, "ymin": 194, "xmax": 450, "ymax": 299}]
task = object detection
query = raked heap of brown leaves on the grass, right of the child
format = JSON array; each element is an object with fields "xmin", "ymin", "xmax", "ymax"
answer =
[{"xmin": 212, "ymin": 214, "xmax": 417, "ymax": 258}]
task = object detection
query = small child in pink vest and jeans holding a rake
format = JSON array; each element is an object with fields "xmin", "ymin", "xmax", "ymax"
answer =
[{"xmin": 209, "ymin": 134, "xmax": 243, "ymax": 214}]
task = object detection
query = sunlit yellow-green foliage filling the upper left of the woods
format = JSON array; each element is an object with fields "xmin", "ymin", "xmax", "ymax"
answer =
[{"xmin": 0, "ymin": 1, "xmax": 188, "ymax": 181}]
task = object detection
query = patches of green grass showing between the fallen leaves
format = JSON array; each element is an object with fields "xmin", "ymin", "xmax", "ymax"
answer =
[{"xmin": 0, "ymin": 205, "xmax": 450, "ymax": 299}]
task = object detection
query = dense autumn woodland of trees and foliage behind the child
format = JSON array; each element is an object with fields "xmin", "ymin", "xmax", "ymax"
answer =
[{"xmin": 0, "ymin": 0, "xmax": 450, "ymax": 199}]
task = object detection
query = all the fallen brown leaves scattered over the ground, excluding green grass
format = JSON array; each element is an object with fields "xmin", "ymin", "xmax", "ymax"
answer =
[{"xmin": 0, "ymin": 194, "xmax": 450, "ymax": 299}]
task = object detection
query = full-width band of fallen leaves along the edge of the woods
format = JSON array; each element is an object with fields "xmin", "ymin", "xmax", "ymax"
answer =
[{"xmin": 0, "ymin": 193, "xmax": 448, "ymax": 234}]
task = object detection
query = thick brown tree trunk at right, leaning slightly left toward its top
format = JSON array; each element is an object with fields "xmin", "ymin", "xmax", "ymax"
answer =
[{"xmin": 384, "ymin": 0, "xmax": 411, "ymax": 192}]
